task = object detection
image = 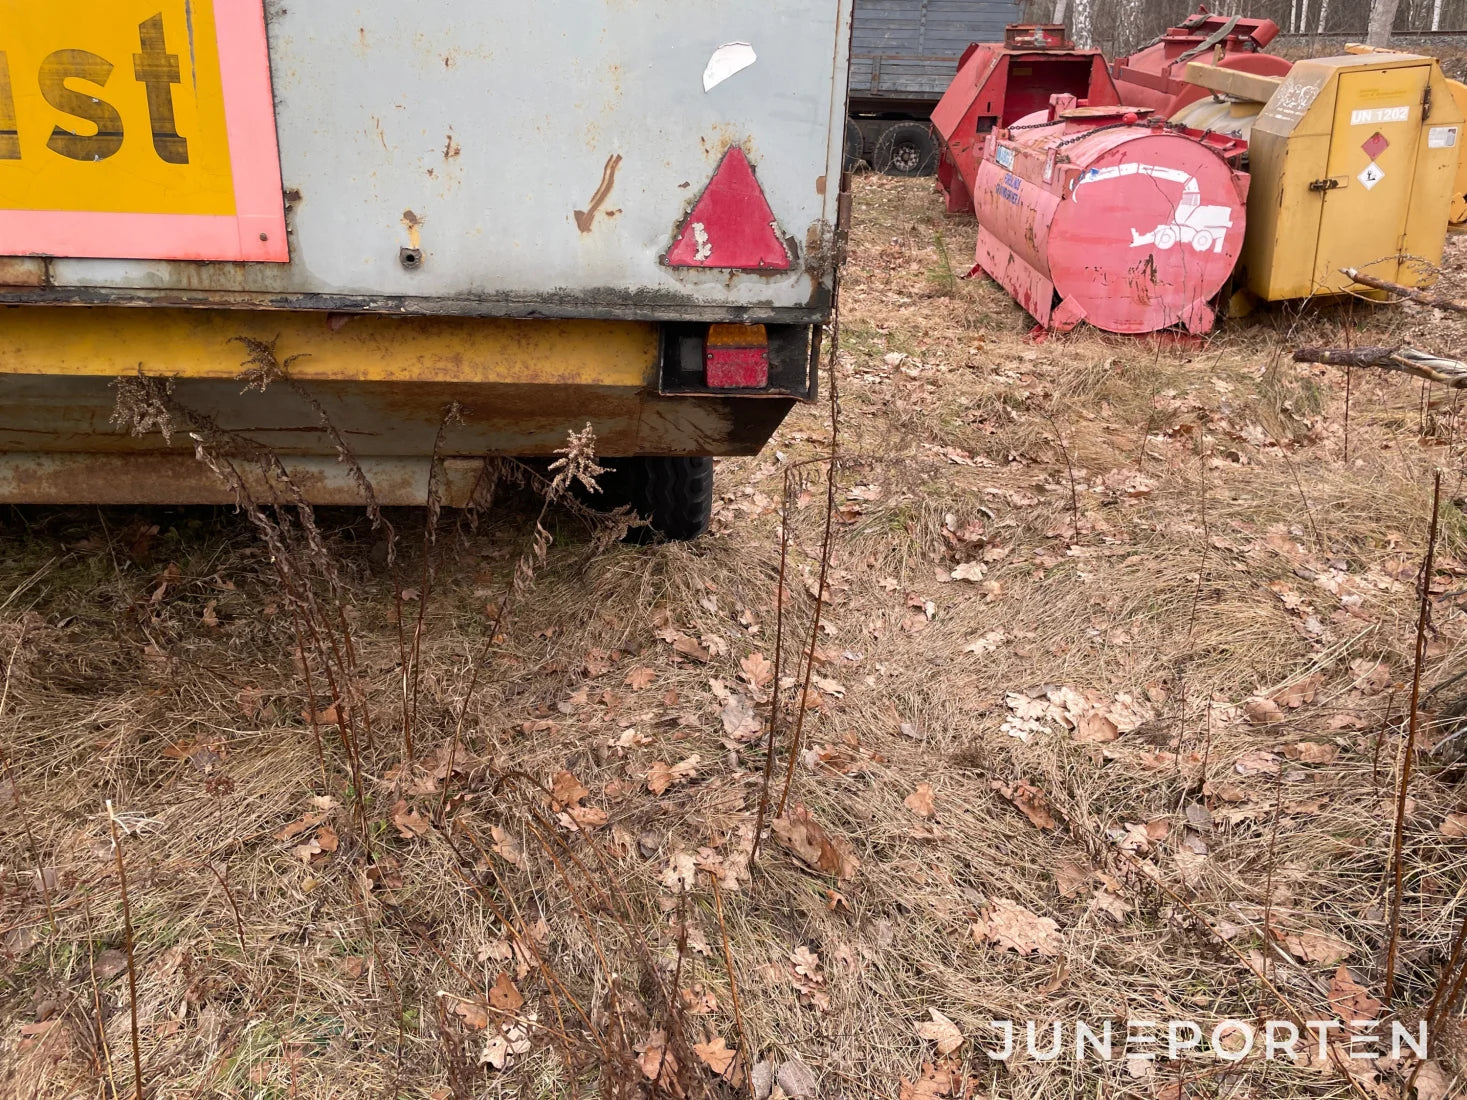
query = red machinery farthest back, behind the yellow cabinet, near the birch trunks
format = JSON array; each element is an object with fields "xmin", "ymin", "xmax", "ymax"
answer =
[{"xmin": 1111, "ymin": 7, "xmax": 1291, "ymax": 119}]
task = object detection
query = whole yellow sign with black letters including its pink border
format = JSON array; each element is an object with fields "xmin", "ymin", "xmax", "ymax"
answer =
[{"xmin": 0, "ymin": 0, "xmax": 289, "ymax": 261}]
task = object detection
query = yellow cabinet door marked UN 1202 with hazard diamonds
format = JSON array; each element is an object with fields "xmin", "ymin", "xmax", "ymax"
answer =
[{"xmin": 1314, "ymin": 65, "xmax": 1425, "ymax": 289}]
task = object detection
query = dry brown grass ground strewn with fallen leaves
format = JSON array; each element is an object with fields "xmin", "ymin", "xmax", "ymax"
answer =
[{"xmin": 0, "ymin": 177, "xmax": 1467, "ymax": 1100}]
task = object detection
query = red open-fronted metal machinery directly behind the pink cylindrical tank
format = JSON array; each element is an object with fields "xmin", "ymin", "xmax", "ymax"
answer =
[{"xmin": 932, "ymin": 23, "xmax": 1121, "ymax": 214}]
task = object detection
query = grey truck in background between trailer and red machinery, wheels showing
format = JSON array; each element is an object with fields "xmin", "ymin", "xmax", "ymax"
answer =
[{"xmin": 845, "ymin": 0, "xmax": 1022, "ymax": 176}]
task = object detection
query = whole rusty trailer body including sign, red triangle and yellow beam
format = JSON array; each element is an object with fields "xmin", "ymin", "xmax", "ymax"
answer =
[{"xmin": 0, "ymin": 0, "xmax": 851, "ymax": 533}]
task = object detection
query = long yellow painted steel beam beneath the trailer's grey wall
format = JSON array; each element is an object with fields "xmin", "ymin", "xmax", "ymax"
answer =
[{"xmin": 0, "ymin": 307, "xmax": 659, "ymax": 389}]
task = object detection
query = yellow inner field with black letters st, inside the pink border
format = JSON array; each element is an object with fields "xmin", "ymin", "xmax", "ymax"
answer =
[{"xmin": 0, "ymin": 0, "xmax": 235, "ymax": 216}]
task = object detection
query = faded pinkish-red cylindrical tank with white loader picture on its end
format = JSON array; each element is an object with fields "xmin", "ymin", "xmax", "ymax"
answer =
[{"xmin": 974, "ymin": 108, "xmax": 1248, "ymax": 340}]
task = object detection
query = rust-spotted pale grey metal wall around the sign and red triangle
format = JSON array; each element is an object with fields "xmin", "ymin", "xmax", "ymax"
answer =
[{"xmin": 0, "ymin": 0, "xmax": 848, "ymax": 321}]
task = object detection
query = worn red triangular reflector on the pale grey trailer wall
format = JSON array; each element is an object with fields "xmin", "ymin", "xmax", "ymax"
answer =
[{"xmin": 666, "ymin": 145, "xmax": 789, "ymax": 271}]
